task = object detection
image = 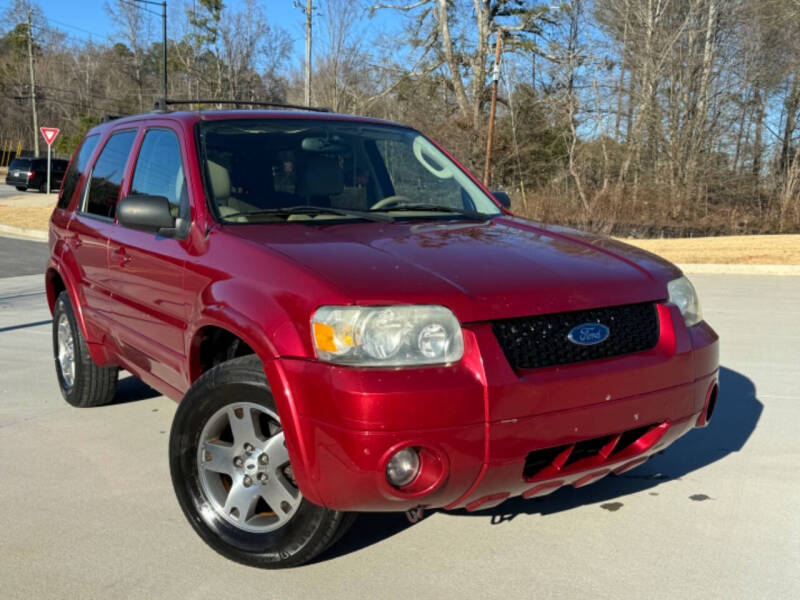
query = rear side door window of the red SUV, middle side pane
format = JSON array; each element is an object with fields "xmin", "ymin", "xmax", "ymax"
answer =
[{"xmin": 86, "ymin": 131, "xmax": 136, "ymax": 218}]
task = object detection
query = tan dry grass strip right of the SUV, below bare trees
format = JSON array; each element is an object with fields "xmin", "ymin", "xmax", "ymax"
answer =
[{"xmin": 622, "ymin": 234, "xmax": 800, "ymax": 265}]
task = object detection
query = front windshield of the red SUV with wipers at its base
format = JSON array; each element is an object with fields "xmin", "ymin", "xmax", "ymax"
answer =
[{"xmin": 200, "ymin": 119, "xmax": 500, "ymax": 223}]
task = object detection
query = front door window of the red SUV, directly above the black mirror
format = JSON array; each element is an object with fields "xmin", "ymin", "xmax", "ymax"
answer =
[{"xmin": 131, "ymin": 129, "xmax": 188, "ymax": 217}]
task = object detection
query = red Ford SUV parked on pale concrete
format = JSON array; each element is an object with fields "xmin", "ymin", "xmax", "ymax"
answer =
[{"xmin": 46, "ymin": 111, "xmax": 718, "ymax": 568}]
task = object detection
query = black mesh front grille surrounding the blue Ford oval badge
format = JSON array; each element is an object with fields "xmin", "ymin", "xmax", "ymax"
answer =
[{"xmin": 492, "ymin": 302, "xmax": 658, "ymax": 369}]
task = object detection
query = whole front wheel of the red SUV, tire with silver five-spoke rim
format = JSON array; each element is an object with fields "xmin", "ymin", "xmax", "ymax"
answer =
[{"xmin": 169, "ymin": 355, "xmax": 353, "ymax": 569}]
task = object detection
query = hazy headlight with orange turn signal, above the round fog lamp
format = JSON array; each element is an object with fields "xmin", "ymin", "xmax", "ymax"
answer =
[{"xmin": 311, "ymin": 306, "xmax": 464, "ymax": 367}]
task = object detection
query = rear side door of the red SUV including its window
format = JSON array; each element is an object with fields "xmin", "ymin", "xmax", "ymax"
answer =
[{"xmin": 67, "ymin": 128, "xmax": 137, "ymax": 340}]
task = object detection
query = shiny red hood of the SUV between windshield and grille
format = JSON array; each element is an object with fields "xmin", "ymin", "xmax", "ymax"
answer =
[{"xmin": 225, "ymin": 217, "xmax": 679, "ymax": 322}]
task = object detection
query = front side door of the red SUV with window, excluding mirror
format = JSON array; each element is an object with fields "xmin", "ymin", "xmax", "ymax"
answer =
[{"xmin": 109, "ymin": 122, "xmax": 189, "ymax": 389}]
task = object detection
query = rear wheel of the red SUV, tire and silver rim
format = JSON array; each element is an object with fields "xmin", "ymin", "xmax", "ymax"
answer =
[{"xmin": 53, "ymin": 292, "xmax": 119, "ymax": 408}]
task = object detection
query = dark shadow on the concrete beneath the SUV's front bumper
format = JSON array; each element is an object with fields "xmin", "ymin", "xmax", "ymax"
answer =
[{"xmin": 318, "ymin": 367, "xmax": 764, "ymax": 561}]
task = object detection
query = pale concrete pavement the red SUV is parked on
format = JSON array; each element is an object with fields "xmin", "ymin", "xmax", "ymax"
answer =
[{"xmin": 0, "ymin": 262, "xmax": 800, "ymax": 600}]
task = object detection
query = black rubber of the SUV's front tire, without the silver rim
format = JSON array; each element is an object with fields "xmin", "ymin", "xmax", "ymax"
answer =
[{"xmin": 169, "ymin": 355, "xmax": 353, "ymax": 569}]
